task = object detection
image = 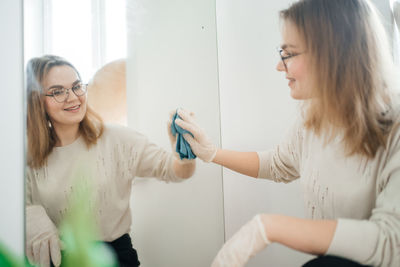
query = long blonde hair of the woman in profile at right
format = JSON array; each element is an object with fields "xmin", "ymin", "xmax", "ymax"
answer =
[{"xmin": 280, "ymin": 0, "xmax": 395, "ymax": 158}]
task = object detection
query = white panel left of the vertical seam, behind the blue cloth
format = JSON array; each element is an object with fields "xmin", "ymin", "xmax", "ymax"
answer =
[{"xmin": 127, "ymin": 0, "xmax": 224, "ymax": 267}]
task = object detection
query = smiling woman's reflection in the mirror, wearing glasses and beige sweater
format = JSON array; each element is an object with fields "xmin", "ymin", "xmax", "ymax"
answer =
[{"xmin": 26, "ymin": 56, "xmax": 195, "ymax": 266}]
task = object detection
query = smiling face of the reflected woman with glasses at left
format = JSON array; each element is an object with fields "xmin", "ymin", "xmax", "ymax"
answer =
[{"xmin": 42, "ymin": 65, "xmax": 86, "ymax": 131}]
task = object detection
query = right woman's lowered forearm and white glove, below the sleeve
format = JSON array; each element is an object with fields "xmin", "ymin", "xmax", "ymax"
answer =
[{"xmin": 211, "ymin": 214, "xmax": 336, "ymax": 267}]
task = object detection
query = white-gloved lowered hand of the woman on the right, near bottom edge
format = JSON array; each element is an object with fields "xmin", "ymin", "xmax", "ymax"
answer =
[{"xmin": 211, "ymin": 214, "xmax": 271, "ymax": 267}]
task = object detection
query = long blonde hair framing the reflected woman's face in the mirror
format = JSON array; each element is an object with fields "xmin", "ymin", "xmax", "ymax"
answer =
[{"xmin": 26, "ymin": 55, "xmax": 104, "ymax": 168}]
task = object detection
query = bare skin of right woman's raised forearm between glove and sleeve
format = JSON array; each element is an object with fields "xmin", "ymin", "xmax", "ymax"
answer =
[{"xmin": 212, "ymin": 149, "xmax": 260, "ymax": 177}]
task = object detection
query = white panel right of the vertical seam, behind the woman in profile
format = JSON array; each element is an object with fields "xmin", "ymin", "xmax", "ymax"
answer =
[{"xmin": 217, "ymin": 0, "xmax": 310, "ymax": 267}]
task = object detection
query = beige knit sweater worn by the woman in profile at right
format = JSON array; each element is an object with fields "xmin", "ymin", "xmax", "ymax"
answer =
[{"xmin": 258, "ymin": 122, "xmax": 400, "ymax": 267}]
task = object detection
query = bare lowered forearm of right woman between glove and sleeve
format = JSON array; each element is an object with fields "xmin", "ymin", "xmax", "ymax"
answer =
[{"xmin": 261, "ymin": 214, "xmax": 337, "ymax": 255}]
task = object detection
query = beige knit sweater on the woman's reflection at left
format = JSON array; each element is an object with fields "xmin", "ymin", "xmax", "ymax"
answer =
[{"xmin": 26, "ymin": 125, "xmax": 182, "ymax": 241}]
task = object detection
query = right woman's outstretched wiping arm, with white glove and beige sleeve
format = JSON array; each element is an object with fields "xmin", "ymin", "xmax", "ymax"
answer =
[{"xmin": 175, "ymin": 109, "xmax": 302, "ymax": 183}]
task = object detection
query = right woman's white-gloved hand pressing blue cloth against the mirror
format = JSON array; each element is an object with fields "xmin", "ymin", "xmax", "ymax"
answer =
[{"xmin": 175, "ymin": 109, "xmax": 217, "ymax": 162}]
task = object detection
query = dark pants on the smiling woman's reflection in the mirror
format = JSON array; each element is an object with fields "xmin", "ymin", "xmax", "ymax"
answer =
[{"xmin": 104, "ymin": 234, "xmax": 140, "ymax": 267}]
